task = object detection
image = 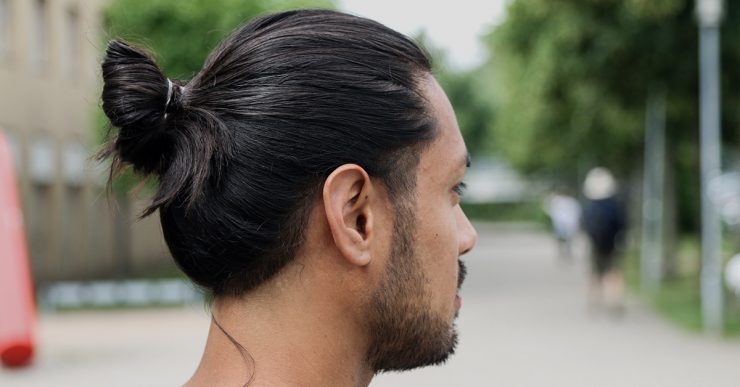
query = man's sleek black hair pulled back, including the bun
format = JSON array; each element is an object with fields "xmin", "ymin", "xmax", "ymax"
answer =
[{"xmin": 101, "ymin": 10, "xmax": 435, "ymax": 296}]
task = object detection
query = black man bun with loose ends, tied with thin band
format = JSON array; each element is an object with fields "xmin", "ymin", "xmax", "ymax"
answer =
[{"xmin": 99, "ymin": 40, "xmax": 230, "ymax": 216}]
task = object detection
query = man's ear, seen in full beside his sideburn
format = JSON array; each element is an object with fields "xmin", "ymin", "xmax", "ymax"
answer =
[{"xmin": 323, "ymin": 164, "xmax": 374, "ymax": 266}]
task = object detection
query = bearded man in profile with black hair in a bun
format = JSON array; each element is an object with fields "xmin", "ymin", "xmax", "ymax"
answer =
[{"xmin": 103, "ymin": 10, "xmax": 476, "ymax": 386}]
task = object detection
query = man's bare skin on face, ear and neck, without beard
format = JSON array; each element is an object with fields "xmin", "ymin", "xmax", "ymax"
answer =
[{"xmin": 185, "ymin": 77, "xmax": 477, "ymax": 387}]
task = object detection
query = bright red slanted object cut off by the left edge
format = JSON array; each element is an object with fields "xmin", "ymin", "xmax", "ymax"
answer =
[{"xmin": 0, "ymin": 130, "xmax": 36, "ymax": 367}]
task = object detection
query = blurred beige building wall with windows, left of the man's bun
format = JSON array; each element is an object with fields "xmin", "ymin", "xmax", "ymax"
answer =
[{"xmin": 0, "ymin": 0, "xmax": 171, "ymax": 283}]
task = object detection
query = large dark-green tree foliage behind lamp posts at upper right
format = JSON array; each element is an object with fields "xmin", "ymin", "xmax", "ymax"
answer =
[{"xmin": 486, "ymin": 0, "xmax": 740, "ymax": 229}]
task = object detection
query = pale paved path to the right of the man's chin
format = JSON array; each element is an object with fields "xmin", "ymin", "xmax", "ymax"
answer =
[{"xmin": 372, "ymin": 225, "xmax": 740, "ymax": 387}]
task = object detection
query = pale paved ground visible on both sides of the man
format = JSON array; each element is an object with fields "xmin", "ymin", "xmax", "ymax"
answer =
[{"xmin": 0, "ymin": 225, "xmax": 740, "ymax": 387}]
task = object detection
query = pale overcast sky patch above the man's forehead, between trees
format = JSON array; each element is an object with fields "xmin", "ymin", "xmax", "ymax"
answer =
[{"xmin": 339, "ymin": 0, "xmax": 506, "ymax": 68}]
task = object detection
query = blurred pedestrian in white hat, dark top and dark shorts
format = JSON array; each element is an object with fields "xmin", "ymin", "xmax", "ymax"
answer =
[{"xmin": 583, "ymin": 167, "xmax": 626, "ymax": 314}]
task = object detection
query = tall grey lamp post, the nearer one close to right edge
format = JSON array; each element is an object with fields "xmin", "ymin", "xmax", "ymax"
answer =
[{"xmin": 696, "ymin": 0, "xmax": 724, "ymax": 334}]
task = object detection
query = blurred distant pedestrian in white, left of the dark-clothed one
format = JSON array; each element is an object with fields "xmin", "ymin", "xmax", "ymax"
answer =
[{"xmin": 543, "ymin": 190, "xmax": 581, "ymax": 261}]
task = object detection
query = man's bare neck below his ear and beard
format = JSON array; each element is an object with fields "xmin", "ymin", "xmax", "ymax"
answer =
[{"xmin": 186, "ymin": 267, "xmax": 373, "ymax": 387}]
